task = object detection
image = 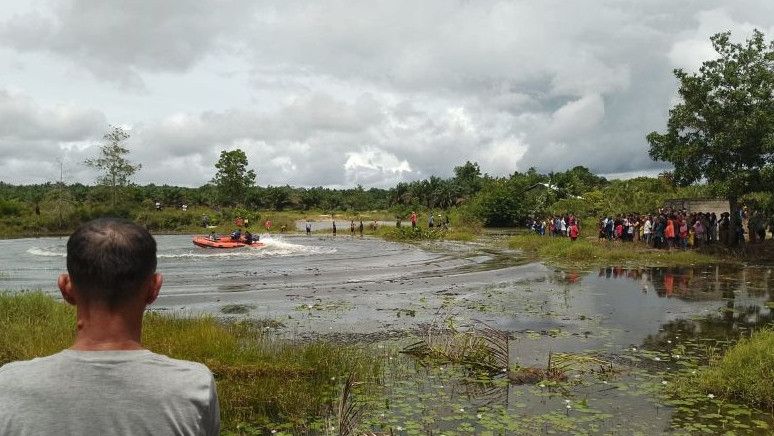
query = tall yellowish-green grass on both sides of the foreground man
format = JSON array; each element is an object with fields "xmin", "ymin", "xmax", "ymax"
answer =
[{"xmin": 0, "ymin": 292, "xmax": 379, "ymax": 434}]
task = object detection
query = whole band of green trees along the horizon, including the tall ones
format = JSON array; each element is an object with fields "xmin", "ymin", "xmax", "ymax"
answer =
[{"xmin": 0, "ymin": 30, "xmax": 774, "ymax": 238}]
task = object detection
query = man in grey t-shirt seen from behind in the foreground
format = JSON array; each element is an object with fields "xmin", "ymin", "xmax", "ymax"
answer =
[{"xmin": 0, "ymin": 218, "xmax": 220, "ymax": 435}]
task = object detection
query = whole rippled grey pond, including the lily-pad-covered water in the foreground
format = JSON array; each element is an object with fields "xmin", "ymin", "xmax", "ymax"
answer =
[{"xmin": 0, "ymin": 235, "xmax": 774, "ymax": 434}]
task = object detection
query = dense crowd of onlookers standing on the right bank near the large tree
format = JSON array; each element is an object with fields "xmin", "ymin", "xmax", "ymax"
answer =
[{"xmin": 527, "ymin": 208, "xmax": 774, "ymax": 249}]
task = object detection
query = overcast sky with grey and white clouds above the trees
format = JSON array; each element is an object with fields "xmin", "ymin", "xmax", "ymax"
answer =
[{"xmin": 0, "ymin": 0, "xmax": 774, "ymax": 187}]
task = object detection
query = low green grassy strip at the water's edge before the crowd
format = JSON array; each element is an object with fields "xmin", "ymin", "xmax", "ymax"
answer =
[{"xmin": 508, "ymin": 233, "xmax": 725, "ymax": 266}]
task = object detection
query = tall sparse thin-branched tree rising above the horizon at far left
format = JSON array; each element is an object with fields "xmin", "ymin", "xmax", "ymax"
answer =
[{"xmin": 84, "ymin": 126, "xmax": 142, "ymax": 208}]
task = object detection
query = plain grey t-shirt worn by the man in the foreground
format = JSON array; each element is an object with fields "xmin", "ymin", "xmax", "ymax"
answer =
[{"xmin": 0, "ymin": 350, "xmax": 220, "ymax": 435}]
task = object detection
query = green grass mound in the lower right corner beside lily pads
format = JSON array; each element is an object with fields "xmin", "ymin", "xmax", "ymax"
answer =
[{"xmin": 695, "ymin": 330, "xmax": 774, "ymax": 412}]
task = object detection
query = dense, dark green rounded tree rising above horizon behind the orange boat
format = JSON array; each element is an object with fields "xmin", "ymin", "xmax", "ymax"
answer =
[{"xmin": 212, "ymin": 148, "xmax": 255, "ymax": 206}]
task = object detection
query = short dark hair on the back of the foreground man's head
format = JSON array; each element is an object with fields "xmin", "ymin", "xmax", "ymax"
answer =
[{"xmin": 67, "ymin": 218, "xmax": 156, "ymax": 309}]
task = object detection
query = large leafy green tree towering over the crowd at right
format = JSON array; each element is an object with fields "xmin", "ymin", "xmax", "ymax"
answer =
[{"xmin": 647, "ymin": 30, "xmax": 774, "ymax": 244}]
